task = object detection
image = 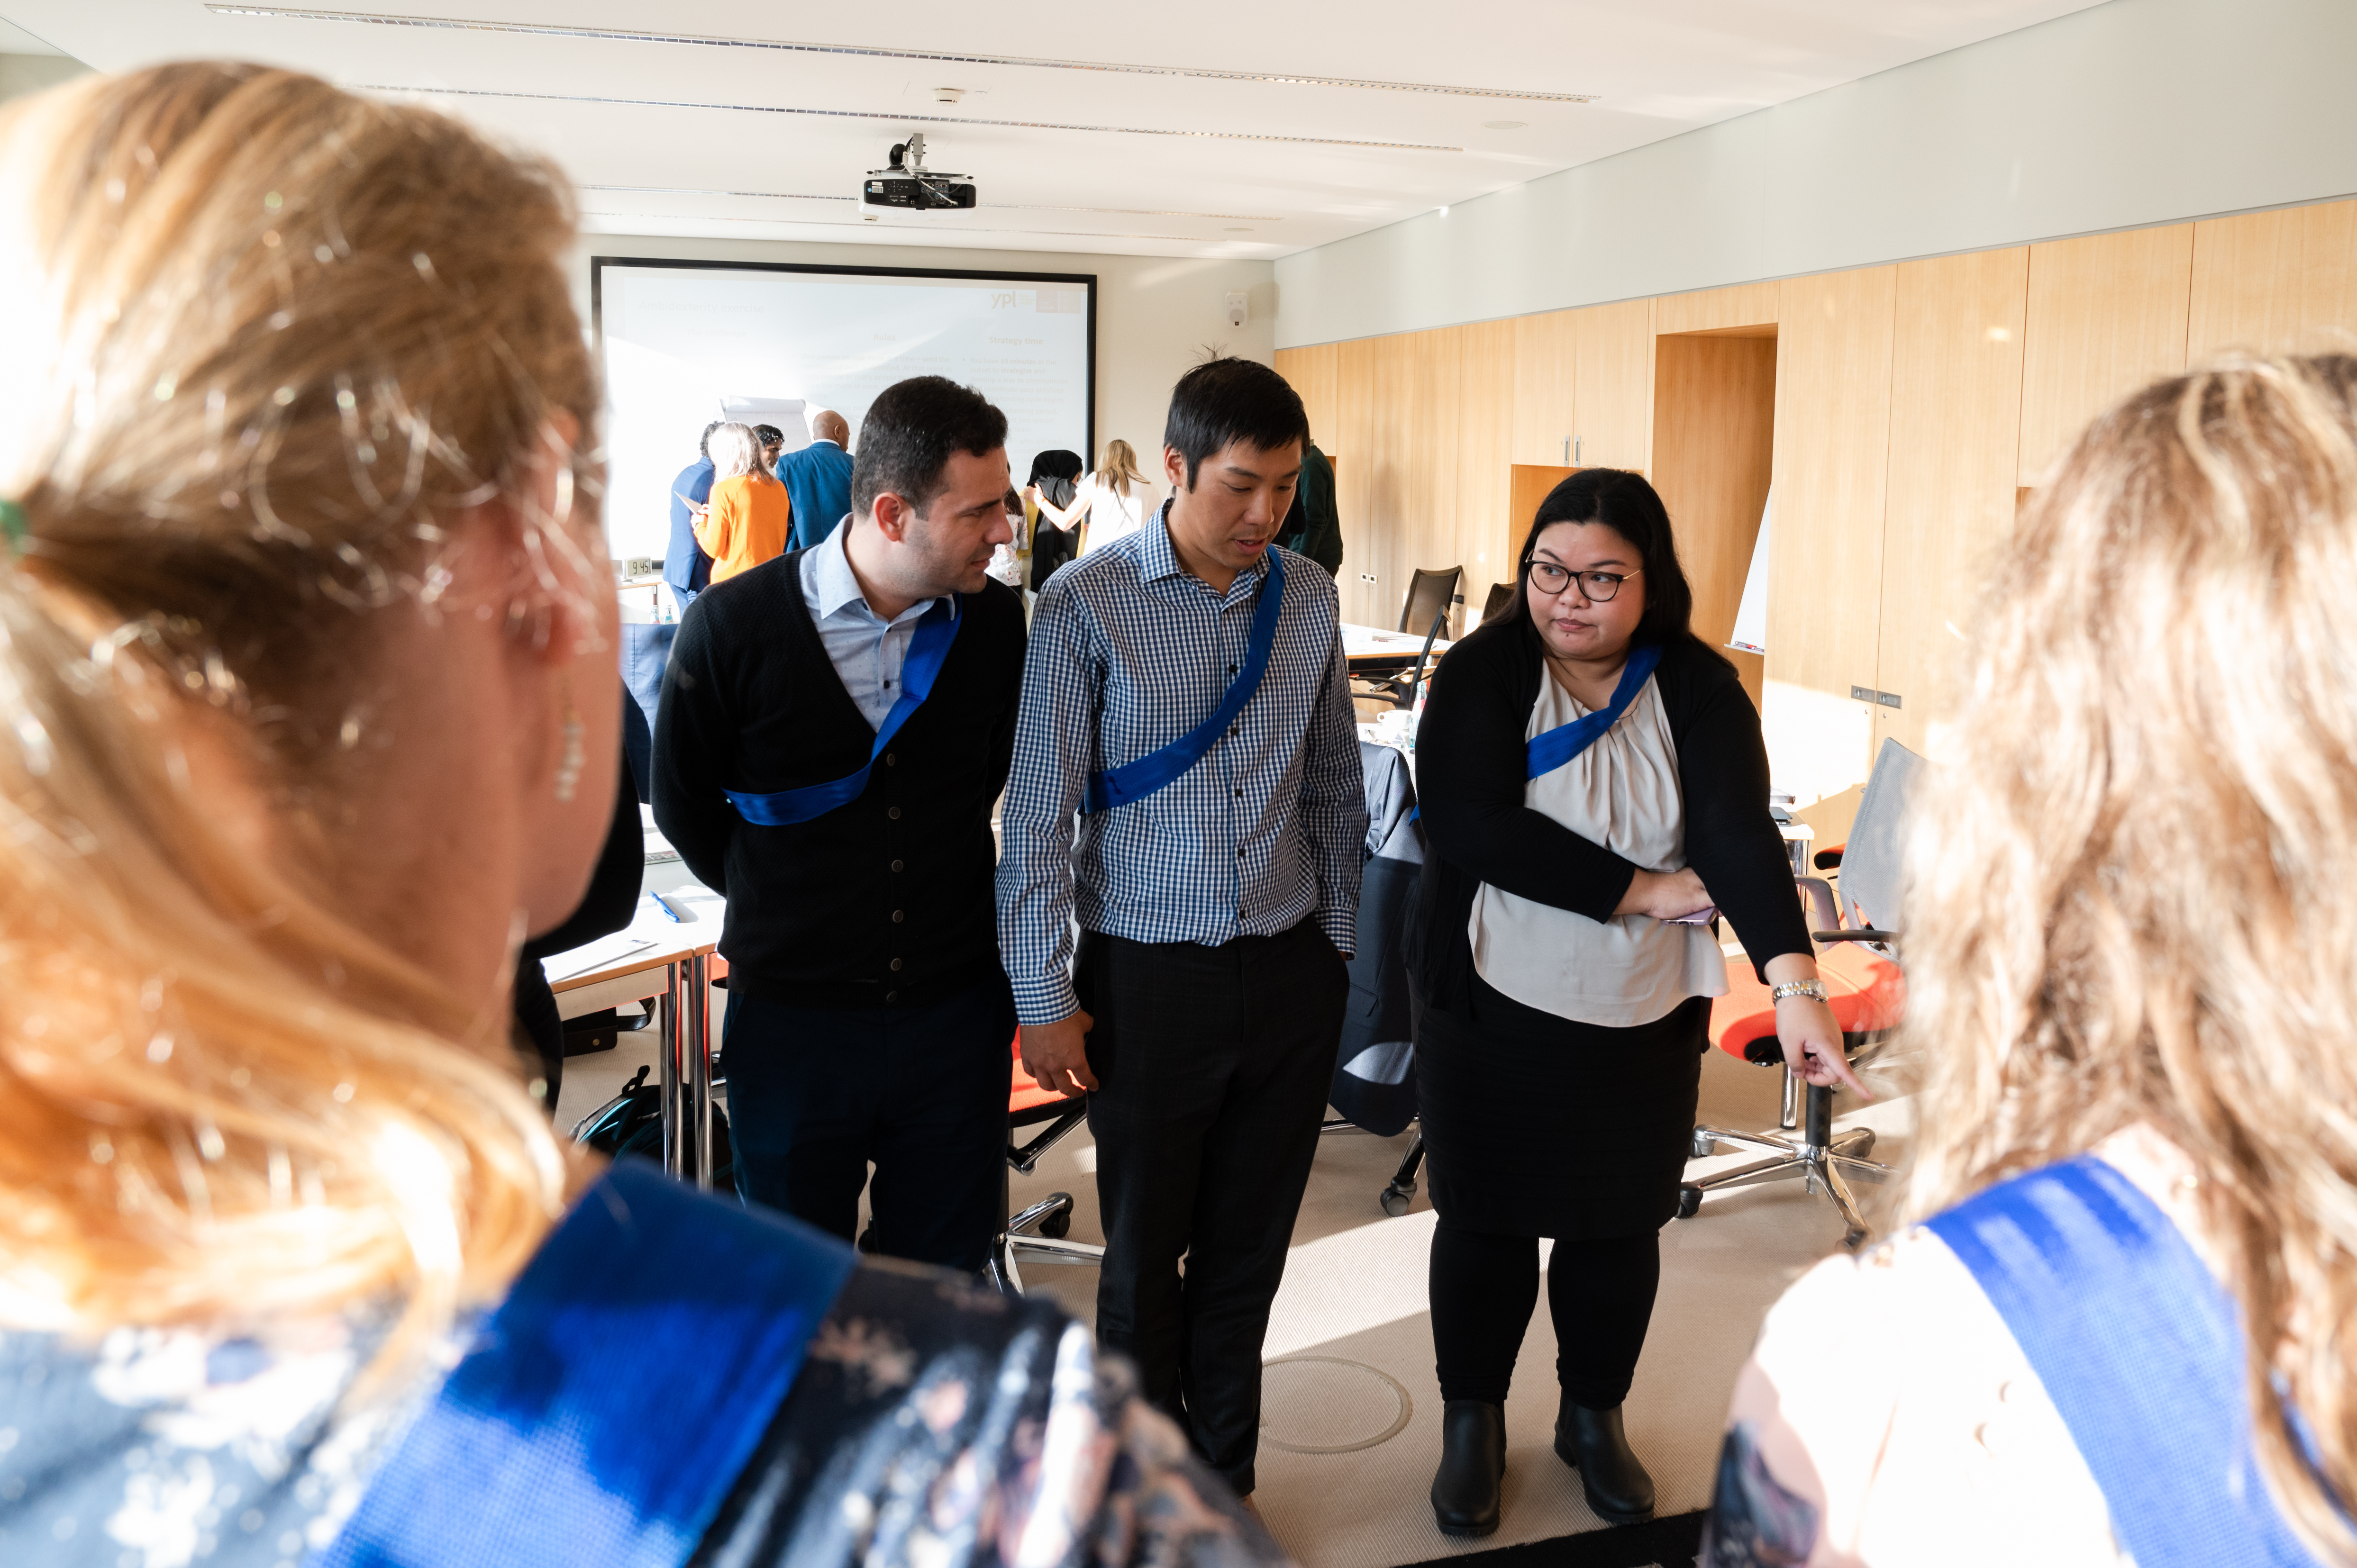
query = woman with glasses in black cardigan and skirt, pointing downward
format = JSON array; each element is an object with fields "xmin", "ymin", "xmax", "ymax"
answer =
[{"xmin": 1412, "ymin": 469, "xmax": 1857, "ymax": 1535}]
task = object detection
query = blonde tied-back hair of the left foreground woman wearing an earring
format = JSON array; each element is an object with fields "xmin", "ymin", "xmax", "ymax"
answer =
[{"xmin": 0, "ymin": 63, "xmax": 603, "ymax": 1360}]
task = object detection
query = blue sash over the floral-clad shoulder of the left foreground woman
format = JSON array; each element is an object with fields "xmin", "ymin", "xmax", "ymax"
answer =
[{"xmin": 316, "ymin": 1160, "xmax": 853, "ymax": 1568}]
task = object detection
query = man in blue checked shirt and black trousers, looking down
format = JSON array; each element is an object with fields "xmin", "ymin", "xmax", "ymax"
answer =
[{"xmin": 997, "ymin": 358, "xmax": 1367, "ymax": 1497}]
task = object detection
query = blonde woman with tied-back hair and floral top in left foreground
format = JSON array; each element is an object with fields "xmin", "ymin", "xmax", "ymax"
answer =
[{"xmin": 0, "ymin": 63, "xmax": 1277, "ymax": 1568}]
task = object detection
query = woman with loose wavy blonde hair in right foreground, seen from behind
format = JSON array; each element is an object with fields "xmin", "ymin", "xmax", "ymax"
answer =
[{"xmin": 1702, "ymin": 358, "xmax": 2357, "ymax": 1568}]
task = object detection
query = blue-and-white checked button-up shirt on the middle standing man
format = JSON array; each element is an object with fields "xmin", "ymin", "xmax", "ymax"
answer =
[{"xmin": 997, "ymin": 502, "xmax": 1367, "ymax": 1024}]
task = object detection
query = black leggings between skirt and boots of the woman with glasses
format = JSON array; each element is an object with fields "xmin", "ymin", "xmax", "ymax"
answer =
[{"xmin": 1431, "ymin": 1219, "xmax": 1662, "ymax": 1410}]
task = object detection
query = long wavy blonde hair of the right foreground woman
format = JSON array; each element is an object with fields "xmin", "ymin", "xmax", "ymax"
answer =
[{"xmin": 1907, "ymin": 358, "xmax": 2357, "ymax": 1563}]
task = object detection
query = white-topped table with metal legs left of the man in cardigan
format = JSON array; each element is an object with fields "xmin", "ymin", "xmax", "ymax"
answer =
[{"xmin": 540, "ymin": 882, "xmax": 728, "ymax": 1188}]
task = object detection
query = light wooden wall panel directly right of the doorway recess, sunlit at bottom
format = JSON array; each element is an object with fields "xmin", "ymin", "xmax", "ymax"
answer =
[{"xmin": 1761, "ymin": 266, "xmax": 1897, "ymax": 830}]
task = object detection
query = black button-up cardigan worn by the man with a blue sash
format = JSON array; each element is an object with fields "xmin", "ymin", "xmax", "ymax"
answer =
[{"xmin": 653, "ymin": 549, "xmax": 1023, "ymax": 1007}]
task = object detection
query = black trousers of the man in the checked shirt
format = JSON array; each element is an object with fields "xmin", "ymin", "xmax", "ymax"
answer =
[{"xmin": 1073, "ymin": 917, "xmax": 1348, "ymax": 1493}]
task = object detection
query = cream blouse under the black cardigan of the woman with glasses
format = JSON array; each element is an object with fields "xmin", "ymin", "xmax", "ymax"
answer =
[{"xmin": 1466, "ymin": 674, "xmax": 1728, "ymax": 1028}]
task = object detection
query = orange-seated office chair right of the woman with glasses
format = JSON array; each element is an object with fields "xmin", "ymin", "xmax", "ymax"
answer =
[{"xmin": 1678, "ymin": 740, "xmax": 1923, "ymax": 1247}]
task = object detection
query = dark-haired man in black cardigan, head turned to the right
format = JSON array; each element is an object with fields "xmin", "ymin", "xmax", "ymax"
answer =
[{"xmin": 653, "ymin": 375, "xmax": 1023, "ymax": 1269}]
